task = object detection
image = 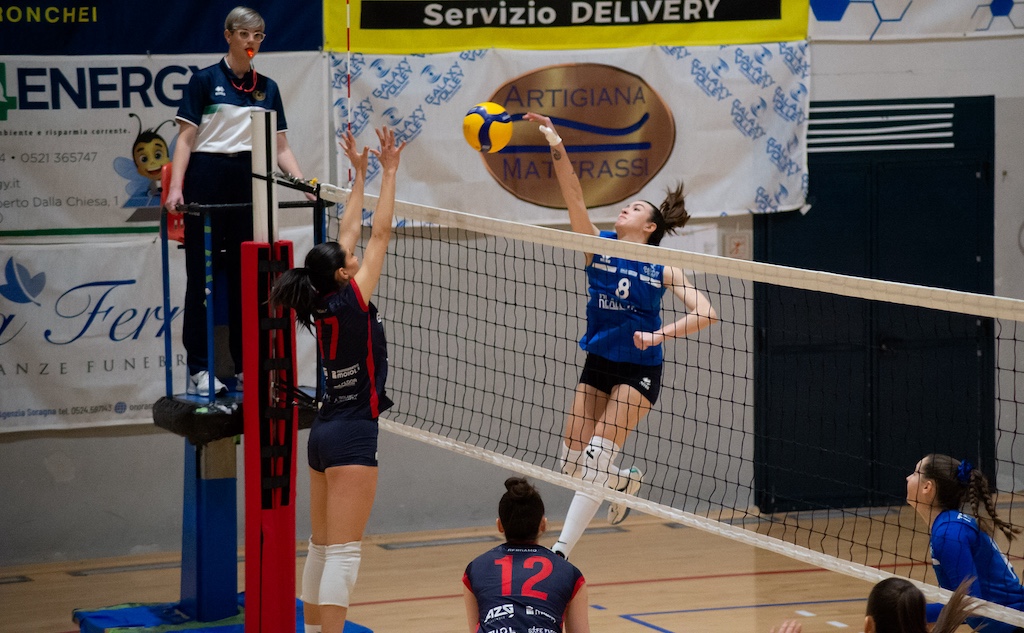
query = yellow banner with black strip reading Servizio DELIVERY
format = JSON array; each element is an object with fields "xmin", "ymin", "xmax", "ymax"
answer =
[{"xmin": 324, "ymin": 0, "xmax": 809, "ymax": 54}]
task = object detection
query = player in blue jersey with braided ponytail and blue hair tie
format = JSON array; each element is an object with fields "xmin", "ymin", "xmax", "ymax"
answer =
[{"xmin": 906, "ymin": 454, "xmax": 1024, "ymax": 633}]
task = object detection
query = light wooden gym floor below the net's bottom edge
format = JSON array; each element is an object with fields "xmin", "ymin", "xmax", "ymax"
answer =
[{"xmin": 0, "ymin": 507, "xmax": 1024, "ymax": 633}]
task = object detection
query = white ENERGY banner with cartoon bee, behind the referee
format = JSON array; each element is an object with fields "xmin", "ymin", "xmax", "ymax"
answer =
[{"xmin": 0, "ymin": 52, "xmax": 329, "ymax": 237}]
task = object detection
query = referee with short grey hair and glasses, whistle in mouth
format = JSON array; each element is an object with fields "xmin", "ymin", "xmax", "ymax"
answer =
[{"xmin": 165, "ymin": 6, "xmax": 302, "ymax": 395}]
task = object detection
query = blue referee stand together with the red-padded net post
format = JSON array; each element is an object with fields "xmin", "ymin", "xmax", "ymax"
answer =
[{"xmin": 73, "ymin": 112, "xmax": 370, "ymax": 633}]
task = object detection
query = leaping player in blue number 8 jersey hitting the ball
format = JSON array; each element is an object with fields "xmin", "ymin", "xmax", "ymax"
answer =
[{"xmin": 523, "ymin": 113, "xmax": 718, "ymax": 556}]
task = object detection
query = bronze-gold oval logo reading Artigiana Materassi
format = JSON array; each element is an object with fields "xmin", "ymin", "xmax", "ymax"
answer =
[{"xmin": 483, "ymin": 64, "xmax": 676, "ymax": 209}]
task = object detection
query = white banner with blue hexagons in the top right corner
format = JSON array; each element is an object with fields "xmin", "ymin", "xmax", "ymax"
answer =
[{"xmin": 808, "ymin": 0, "xmax": 1024, "ymax": 41}]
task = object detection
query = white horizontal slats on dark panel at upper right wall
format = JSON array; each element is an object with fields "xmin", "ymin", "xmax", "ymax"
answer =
[{"xmin": 807, "ymin": 101, "xmax": 955, "ymax": 154}]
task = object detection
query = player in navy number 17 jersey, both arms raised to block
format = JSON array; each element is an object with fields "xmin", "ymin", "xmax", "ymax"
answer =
[{"xmin": 270, "ymin": 127, "xmax": 406, "ymax": 633}]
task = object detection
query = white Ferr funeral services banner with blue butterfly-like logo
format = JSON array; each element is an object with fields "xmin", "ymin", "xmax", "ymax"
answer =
[{"xmin": 0, "ymin": 227, "xmax": 316, "ymax": 432}]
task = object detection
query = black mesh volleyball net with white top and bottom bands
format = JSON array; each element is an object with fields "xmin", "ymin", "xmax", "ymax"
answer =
[{"xmin": 367, "ymin": 195, "xmax": 1024, "ymax": 626}]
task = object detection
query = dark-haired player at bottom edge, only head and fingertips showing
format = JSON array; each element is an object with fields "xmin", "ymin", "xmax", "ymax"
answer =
[{"xmin": 771, "ymin": 578, "xmax": 975, "ymax": 633}]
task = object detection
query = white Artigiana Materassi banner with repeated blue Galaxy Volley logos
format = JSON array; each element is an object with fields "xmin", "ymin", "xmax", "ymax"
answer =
[{"xmin": 331, "ymin": 42, "xmax": 810, "ymax": 220}]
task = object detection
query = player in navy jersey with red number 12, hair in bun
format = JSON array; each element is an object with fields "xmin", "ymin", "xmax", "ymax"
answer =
[{"xmin": 462, "ymin": 477, "xmax": 590, "ymax": 633}]
